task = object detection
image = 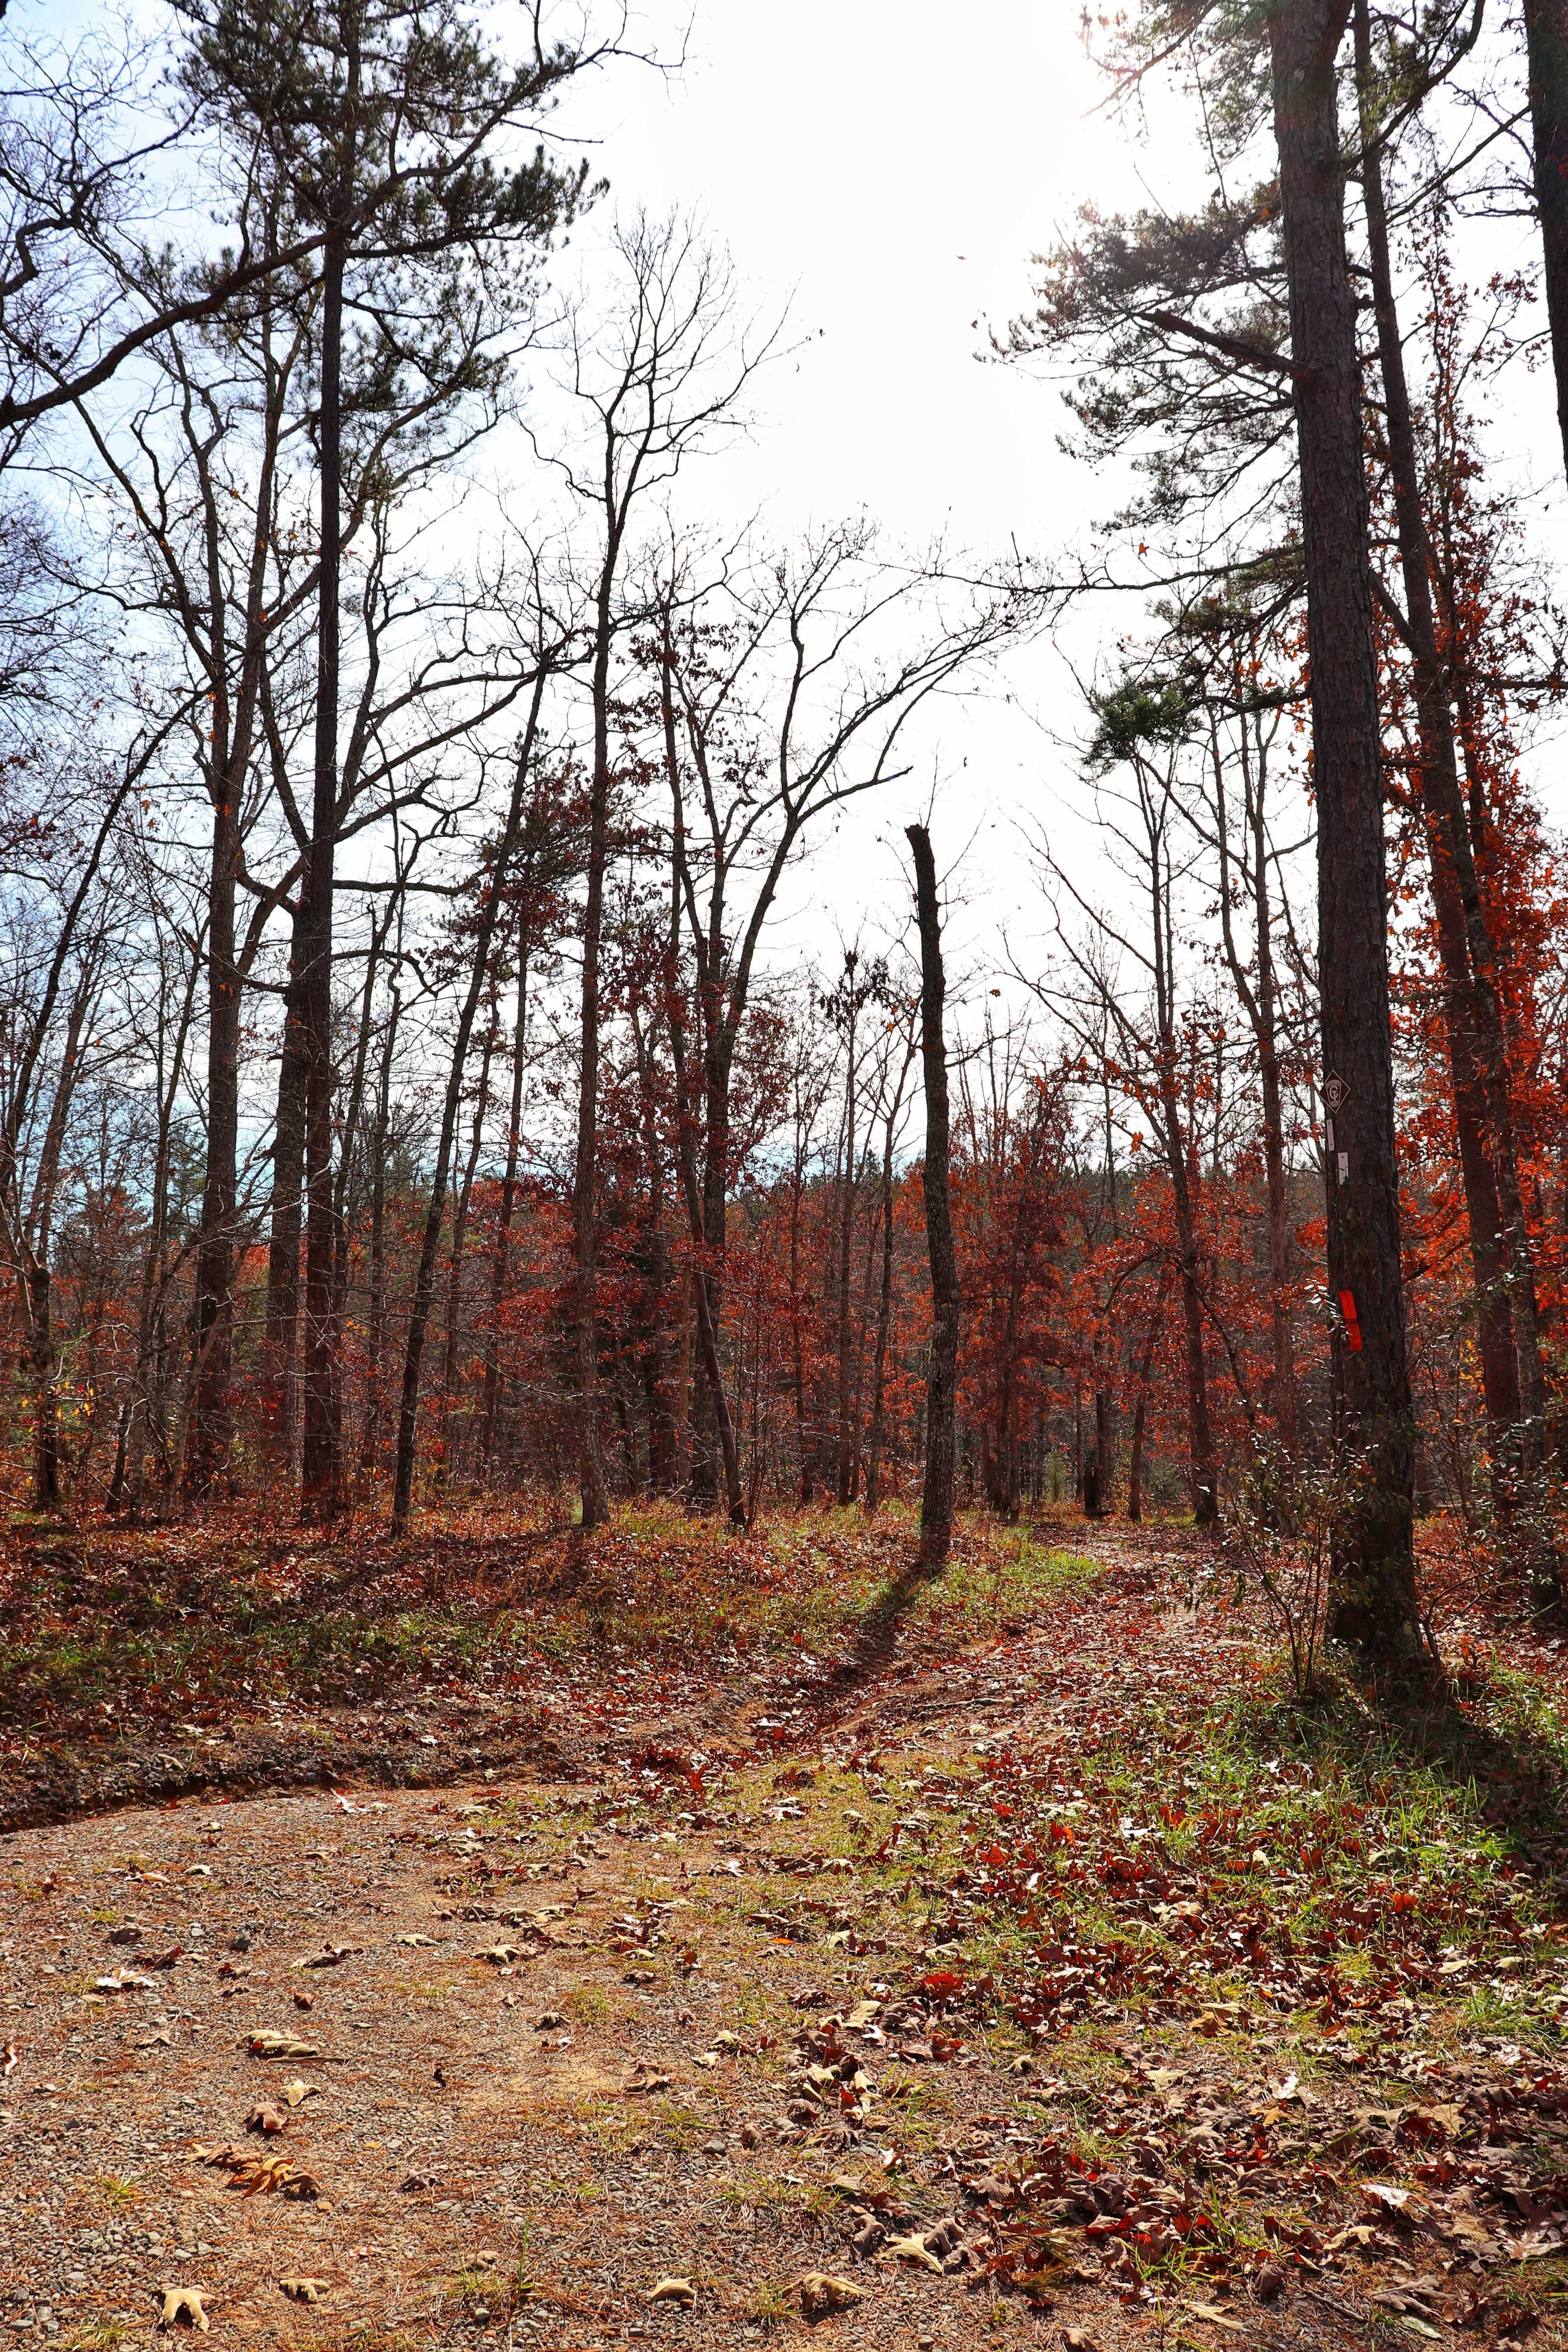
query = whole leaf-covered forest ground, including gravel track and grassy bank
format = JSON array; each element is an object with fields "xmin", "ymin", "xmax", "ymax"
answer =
[{"xmin": 0, "ymin": 1512, "xmax": 1568, "ymax": 2352}]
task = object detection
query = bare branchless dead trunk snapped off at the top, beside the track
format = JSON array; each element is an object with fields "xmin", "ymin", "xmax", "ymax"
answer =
[{"xmin": 905, "ymin": 826, "xmax": 959, "ymax": 1576}]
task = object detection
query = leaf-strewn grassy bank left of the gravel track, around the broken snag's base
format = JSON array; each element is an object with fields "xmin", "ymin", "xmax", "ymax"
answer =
[{"xmin": 0, "ymin": 1505, "xmax": 1086, "ymax": 1740}]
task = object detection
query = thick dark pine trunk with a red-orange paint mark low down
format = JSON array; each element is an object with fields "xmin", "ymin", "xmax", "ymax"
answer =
[{"xmin": 1269, "ymin": 0, "xmax": 1425, "ymax": 1663}]
